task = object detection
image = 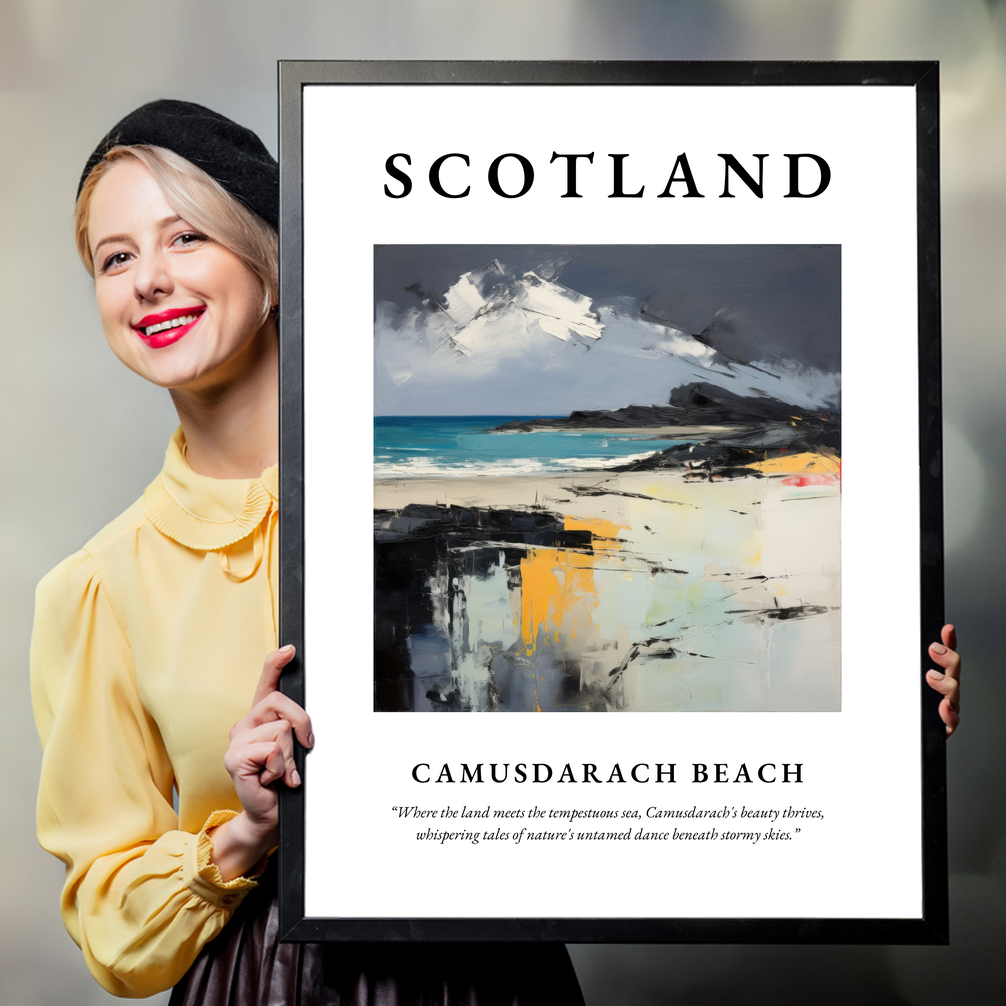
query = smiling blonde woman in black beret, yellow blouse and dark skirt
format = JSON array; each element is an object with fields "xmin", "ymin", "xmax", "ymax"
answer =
[{"xmin": 32, "ymin": 102, "xmax": 582, "ymax": 1006}]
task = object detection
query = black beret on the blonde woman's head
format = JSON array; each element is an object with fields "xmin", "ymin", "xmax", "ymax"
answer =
[{"xmin": 76, "ymin": 99, "xmax": 280, "ymax": 227}]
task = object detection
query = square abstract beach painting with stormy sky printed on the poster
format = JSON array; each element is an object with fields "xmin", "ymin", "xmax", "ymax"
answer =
[{"xmin": 373, "ymin": 244, "xmax": 841, "ymax": 712}]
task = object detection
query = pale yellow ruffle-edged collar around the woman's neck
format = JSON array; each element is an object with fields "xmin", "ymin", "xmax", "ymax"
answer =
[{"xmin": 143, "ymin": 427, "xmax": 280, "ymax": 551}]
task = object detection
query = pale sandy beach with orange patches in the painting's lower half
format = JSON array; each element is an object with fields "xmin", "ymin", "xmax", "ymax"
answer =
[{"xmin": 374, "ymin": 455, "xmax": 841, "ymax": 710}]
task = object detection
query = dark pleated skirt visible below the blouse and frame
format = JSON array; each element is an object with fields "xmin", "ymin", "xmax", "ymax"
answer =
[{"xmin": 169, "ymin": 870, "xmax": 583, "ymax": 1006}]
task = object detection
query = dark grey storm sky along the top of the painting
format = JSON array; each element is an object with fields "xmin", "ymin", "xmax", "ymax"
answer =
[{"xmin": 374, "ymin": 244, "xmax": 841, "ymax": 371}]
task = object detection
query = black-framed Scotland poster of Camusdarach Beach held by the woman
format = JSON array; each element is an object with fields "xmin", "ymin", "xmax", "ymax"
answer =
[{"xmin": 280, "ymin": 62, "xmax": 947, "ymax": 943}]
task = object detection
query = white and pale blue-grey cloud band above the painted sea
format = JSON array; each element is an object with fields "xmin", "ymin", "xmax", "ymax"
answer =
[{"xmin": 374, "ymin": 261, "xmax": 839, "ymax": 415}]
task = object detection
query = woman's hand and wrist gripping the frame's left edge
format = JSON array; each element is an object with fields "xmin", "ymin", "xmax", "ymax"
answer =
[{"xmin": 209, "ymin": 646, "xmax": 314, "ymax": 880}]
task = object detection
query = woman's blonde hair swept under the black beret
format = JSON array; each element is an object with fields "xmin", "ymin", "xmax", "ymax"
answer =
[{"xmin": 73, "ymin": 145, "xmax": 280, "ymax": 323}]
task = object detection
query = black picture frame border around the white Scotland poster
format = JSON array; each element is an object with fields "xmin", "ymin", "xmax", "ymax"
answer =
[{"xmin": 279, "ymin": 61, "xmax": 949, "ymax": 944}]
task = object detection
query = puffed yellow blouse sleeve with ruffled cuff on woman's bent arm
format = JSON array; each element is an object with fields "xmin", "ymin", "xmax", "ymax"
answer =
[{"xmin": 31, "ymin": 551, "xmax": 256, "ymax": 997}]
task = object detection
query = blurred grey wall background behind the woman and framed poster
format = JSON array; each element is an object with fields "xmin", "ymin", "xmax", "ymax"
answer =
[{"xmin": 0, "ymin": 0, "xmax": 1006, "ymax": 1006}]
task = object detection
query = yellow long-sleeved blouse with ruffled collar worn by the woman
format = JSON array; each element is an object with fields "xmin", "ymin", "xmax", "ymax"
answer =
[{"xmin": 31, "ymin": 430, "xmax": 278, "ymax": 997}]
